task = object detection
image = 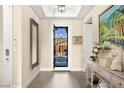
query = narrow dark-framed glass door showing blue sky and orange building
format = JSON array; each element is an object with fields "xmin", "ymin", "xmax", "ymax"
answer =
[{"xmin": 53, "ymin": 26, "xmax": 68, "ymax": 68}]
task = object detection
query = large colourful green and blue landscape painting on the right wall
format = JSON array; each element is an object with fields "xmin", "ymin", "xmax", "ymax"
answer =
[{"xmin": 99, "ymin": 5, "xmax": 124, "ymax": 45}]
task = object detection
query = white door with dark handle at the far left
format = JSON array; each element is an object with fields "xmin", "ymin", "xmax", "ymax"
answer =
[{"xmin": 3, "ymin": 5, "xmax": 12, "ymax": 87}]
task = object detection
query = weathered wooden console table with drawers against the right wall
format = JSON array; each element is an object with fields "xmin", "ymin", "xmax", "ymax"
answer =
[{"xmin": 86, "ymin": 60, "xmax": 124, "ymax": 88}]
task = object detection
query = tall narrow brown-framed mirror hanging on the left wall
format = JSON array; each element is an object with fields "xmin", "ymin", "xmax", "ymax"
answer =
[{"xmin": 30, "ymin": 18, "xmax": 39, "ymax": 69}]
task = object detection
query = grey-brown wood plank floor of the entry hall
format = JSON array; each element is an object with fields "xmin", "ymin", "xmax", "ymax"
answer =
[{"xmin": 28, "ymin": 71, "xmax": 86, "ymax": 88}]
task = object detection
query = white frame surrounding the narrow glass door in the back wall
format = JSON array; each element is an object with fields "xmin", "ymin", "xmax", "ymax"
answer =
[{"xmin": 52, "ymin": 24, "xmax": 70, "ymax": 71}]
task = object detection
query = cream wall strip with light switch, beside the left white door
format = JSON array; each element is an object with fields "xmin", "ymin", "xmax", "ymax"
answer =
[{"xmin": 12, "ymin": 6, "xmax": 22, "ymax": 87}]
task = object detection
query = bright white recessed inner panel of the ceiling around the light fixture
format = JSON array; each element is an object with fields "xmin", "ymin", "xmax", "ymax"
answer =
[{"xmin": 41, "ymin": 5, "xmax": 82, "ymax": 17}]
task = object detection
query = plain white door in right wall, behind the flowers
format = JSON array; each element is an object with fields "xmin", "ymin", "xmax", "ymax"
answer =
[{"xmin": 83, "ymin": 24, "xmax": 93, "ymax": 71}]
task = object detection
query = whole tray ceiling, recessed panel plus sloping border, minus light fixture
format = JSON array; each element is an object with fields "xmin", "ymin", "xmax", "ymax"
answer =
[{"xmin": 31, "ymin": 5, "xmax": 93, "ymax": 19}]
